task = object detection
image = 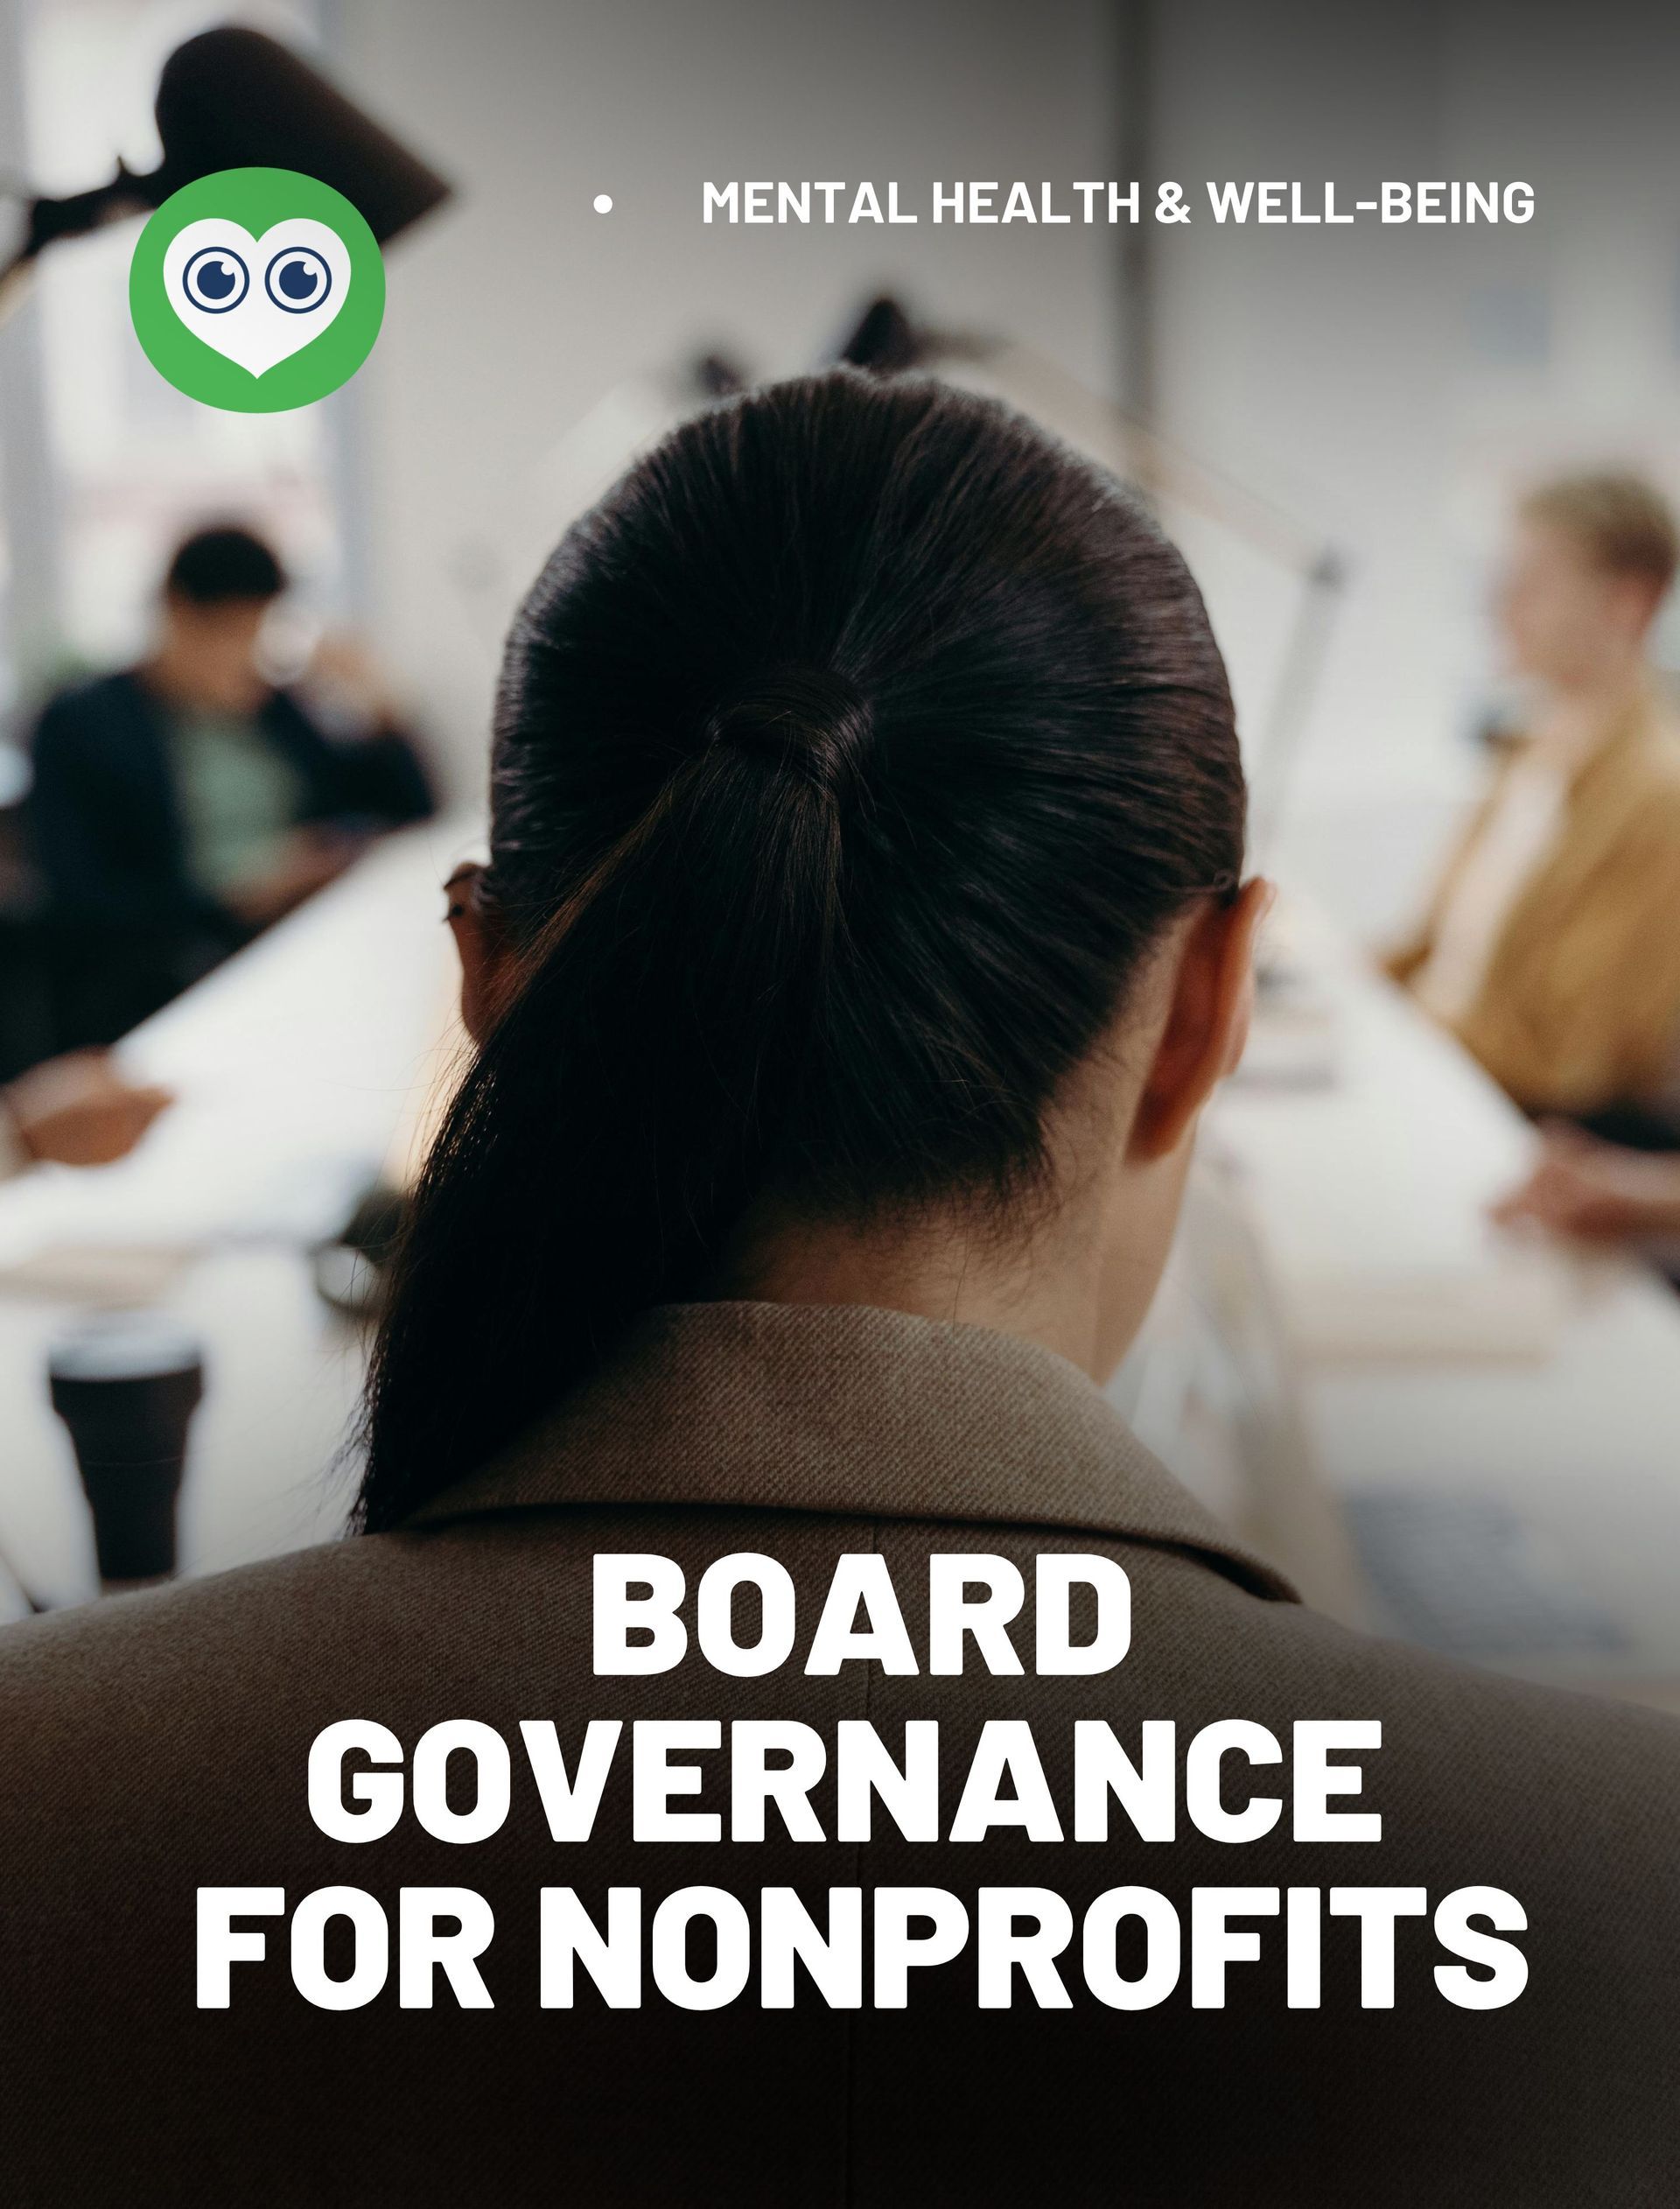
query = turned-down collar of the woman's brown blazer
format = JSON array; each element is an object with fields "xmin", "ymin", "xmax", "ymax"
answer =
[{"xmin": 409, "ymin": 1303, "xmax": 1298, "ymax": 1602}]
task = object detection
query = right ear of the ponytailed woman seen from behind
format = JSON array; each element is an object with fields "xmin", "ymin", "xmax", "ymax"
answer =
[{"xmin": 1128, "ymin": 875, "xmax": 1278, "ymax": 1162}]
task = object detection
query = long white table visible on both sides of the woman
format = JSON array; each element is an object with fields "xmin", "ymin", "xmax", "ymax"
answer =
[{"xmin": 0, "ymin": 824, "xmax": 1680, "ymax": 1699}]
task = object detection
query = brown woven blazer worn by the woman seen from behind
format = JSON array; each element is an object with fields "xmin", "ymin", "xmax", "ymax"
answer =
[{"xmin": 0, "ymin": 1303, "xmax": 1680, "ymax": 2209}]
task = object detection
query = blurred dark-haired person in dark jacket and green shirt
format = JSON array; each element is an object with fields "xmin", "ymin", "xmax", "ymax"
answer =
[{"xmin": 29, "ymin": 528, "xmax": 433, "ymax": 1047}]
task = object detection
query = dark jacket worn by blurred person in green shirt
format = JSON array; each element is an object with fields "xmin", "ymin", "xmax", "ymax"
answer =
[{"xmin": 26, "ymin": 670, "xmax": 433, "ymax": 1049}]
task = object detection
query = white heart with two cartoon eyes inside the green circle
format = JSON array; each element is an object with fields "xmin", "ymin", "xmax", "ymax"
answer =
[{"xmin": 164, "ymin": 214, "xmax": 351, "ymax": 375}]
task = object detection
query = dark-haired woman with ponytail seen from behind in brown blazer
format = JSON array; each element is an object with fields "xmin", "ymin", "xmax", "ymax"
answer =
[{"xmin": 0, "ymin": 371, "xmax": 1680, "ymax": 2209}]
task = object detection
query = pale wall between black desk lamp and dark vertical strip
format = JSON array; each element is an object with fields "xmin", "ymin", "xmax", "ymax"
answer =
[{"xmin": 338, "ymin": 0, "xmax": 1117, "ymax": 784}]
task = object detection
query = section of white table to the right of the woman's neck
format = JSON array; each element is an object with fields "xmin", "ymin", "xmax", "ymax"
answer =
[{"xmin": 1208, "ymin": 912, "xmax": 1680, "ymax": 1708}]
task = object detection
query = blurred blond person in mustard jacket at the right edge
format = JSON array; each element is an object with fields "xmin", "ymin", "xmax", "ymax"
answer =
[{"xmin": 1389, "ymin": 475, "xmax": 1680, "ymax": 1133}]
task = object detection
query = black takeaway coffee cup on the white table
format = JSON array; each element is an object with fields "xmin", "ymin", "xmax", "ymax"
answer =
[{"xmin": 46, "ymin": 1312, "xmax": 203, "ymax": 1588}]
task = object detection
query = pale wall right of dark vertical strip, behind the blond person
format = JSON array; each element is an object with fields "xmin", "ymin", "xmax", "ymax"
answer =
[{"xmin": 1157, "ymin": 0, "xmax": 1680, "ymax": 930}]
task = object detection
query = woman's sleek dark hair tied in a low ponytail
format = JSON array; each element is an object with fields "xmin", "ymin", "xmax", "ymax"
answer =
[{"xmin": 358, "ymin": 371, "xmax": 1242, "ymax": 1529}]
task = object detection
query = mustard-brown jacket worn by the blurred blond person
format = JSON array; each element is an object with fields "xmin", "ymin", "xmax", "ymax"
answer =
[{"xmin": 1389, "ymin": 707, "xmax": 1680, "ymax": 1113}]
